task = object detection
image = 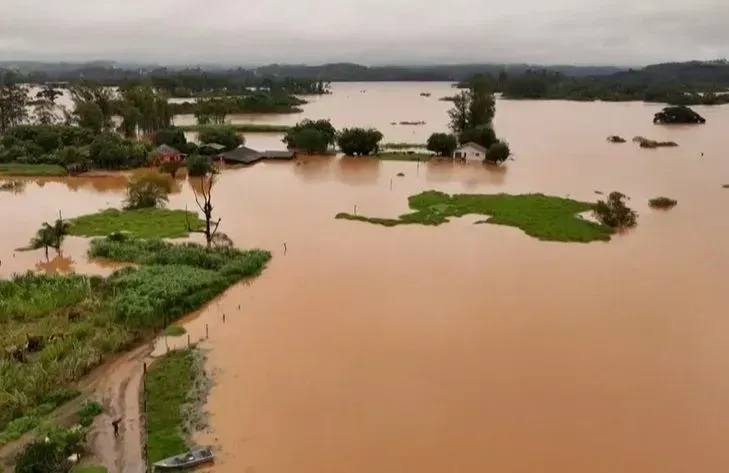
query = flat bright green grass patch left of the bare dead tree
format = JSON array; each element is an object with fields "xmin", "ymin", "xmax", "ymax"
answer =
[{"xmin": 71, "ymin": 208, "xmax": 204, "ymax": 238}]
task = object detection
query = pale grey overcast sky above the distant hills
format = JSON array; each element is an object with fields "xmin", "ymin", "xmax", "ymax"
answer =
[{"xmin": 0, "ymin": 0, "xmax": 729, "ymax": 65}]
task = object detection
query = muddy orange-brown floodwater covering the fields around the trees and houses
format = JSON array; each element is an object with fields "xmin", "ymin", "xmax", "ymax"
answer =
[{"xmin": 0, "ymin": 84, "xmax": 729, "ymax": 473}]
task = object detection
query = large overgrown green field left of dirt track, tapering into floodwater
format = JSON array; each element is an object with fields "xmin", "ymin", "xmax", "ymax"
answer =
[{"xmin": 0, "ymin": 235, "xmax": 271, "ymax": 436}]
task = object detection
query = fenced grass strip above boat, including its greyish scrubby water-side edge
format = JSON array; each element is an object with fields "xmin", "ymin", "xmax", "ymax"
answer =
[{"xmin": 146, "ymin": 350, "xmax": 209, "ymax": 462}]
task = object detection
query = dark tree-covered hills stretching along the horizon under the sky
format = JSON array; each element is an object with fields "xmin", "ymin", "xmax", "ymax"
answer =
[{"xmin": 0, "ymin": 60, "xmax": 729, "ymax": 105}]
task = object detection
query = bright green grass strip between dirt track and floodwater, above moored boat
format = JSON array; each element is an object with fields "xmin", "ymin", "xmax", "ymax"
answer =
[{"xmin": 147, "ymin": 350, "xmax": 195, "ymax": 462}]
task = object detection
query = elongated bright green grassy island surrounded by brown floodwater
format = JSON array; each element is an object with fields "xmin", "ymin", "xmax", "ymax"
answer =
[{"xmin": 336, "ymin": 191, "xmax": 613, "ymax": 242}]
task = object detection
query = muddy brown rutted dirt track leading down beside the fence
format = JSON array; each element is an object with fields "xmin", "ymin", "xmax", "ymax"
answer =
[{"xmin": 0, "ymin": 343, "xmax": 153, "ymax": 473}]
